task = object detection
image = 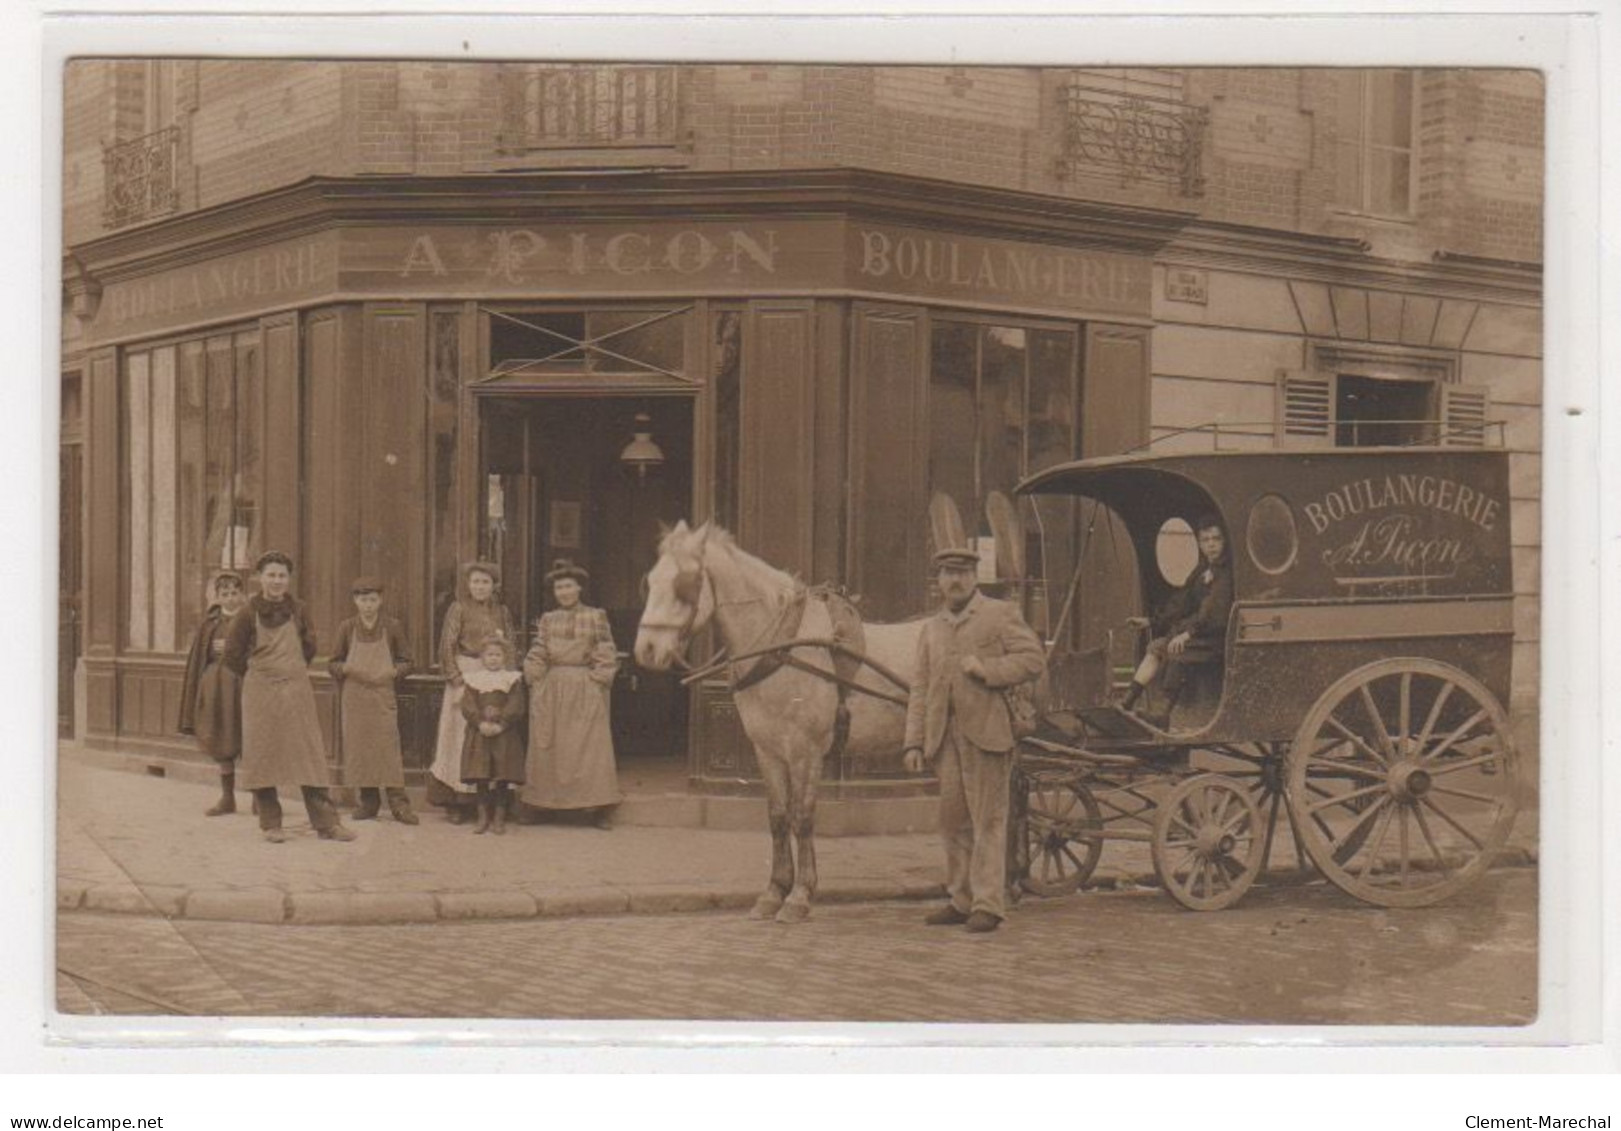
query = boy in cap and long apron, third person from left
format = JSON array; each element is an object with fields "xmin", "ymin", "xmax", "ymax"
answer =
[{"xmin": 329, "ymin": 577, "xmax": 417, "ymax": 825}]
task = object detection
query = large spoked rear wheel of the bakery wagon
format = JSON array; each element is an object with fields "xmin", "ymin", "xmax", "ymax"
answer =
[{"xmin": 1289, "ymin": 658, "xmax": 1519, "ymax": 907}]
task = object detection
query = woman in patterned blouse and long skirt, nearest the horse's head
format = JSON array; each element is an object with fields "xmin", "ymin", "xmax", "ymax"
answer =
[{"xmin": 520, "ymin": 561, "xmax": 622, "ymax": 828}]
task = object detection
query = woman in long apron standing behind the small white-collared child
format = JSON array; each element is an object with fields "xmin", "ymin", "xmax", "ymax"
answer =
[{"xmin": 428, "ymin": 562, "xmax": 512, "ymax": 825}]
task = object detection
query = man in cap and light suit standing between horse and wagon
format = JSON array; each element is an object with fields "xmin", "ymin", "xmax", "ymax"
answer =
[{"xmin": 905, "ymin": 548, "xmax": 1046, "ymax": 933}]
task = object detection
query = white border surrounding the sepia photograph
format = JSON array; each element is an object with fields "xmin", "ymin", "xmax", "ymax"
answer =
[{"xmin": 9, "ymin": 0, "xmax": 1621, "ymax": 1071}]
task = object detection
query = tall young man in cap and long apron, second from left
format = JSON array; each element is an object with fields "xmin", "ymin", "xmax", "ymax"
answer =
[{"xmin": 225, "ymin": 549, "xmax": 355, "ymax": 844}]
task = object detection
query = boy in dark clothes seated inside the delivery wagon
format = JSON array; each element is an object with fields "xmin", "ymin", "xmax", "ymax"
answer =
[{"xmin": 1120, "ymin": 514, "xmax": 1232, "ymax": 731}]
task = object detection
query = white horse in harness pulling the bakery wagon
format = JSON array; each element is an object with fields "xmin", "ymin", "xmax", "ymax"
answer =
[{"xmin": 635, "ymin": 522, "xmax": 924, "ymax": 924}]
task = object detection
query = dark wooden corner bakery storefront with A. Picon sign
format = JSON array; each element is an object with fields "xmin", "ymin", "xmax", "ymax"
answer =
[{"xmin": 66, "ymin": 172, "xmax": 1187, "ymax": 789}]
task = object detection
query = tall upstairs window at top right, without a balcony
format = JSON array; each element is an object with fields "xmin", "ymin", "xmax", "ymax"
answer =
[{"xmin": 1334, "ymin": 70, "xmax": 1417, "ymax": 219}]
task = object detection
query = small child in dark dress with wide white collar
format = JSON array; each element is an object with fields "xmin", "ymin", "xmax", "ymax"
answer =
[{"xmin": 462, "ymin": 632, "xmax": 528, "ymax": 836}]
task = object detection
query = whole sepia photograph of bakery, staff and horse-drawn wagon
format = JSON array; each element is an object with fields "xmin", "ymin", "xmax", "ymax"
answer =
[{"xmin": 47, "ymin": 59, "xmax": 1546, "ymax": 1040}]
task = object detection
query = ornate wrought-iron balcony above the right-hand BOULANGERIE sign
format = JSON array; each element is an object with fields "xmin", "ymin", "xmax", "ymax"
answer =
[{"xmin": 1057, "ymin": 83, "xmax": 1209, "ymax": 196}]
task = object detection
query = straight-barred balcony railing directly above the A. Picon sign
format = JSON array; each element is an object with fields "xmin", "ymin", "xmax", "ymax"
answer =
[{"xmin": 501, "ymin": 66, "xmax": 681, "ymax": 152}]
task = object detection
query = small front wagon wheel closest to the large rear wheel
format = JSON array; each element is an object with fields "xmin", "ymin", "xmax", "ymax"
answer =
[{"xmin": 1151, "ymin": 773, "xmax": 1264, "ymax": 911}]
